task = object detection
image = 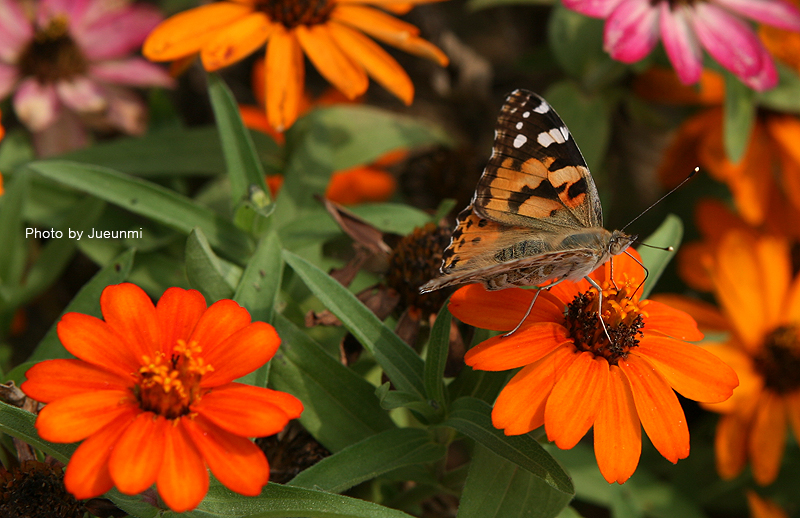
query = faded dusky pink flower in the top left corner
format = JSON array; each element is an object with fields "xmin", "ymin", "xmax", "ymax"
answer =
[{"xmin": 0, "ymin": 0, "xmax": 172, "ymax": 154}]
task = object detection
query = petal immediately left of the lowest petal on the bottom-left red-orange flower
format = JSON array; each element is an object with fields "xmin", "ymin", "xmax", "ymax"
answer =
[{"xmin": 108, "ymin": 412, "xmax": 172, "ymax": 495}]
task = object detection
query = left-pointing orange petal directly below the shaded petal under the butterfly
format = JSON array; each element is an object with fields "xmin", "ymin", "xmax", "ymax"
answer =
[{"xmin": 464, "ymin": 322, "xmax": 572, "ymax": 371}]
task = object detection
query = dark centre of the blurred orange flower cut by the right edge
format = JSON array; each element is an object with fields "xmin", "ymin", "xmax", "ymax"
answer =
[{"xmin": 753, "ymin": 326, "xmax": 800, "ymax": 394}]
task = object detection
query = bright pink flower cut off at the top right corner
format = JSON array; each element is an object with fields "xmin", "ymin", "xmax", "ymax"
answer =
[{"xmin": 563, "ymin": 0, "xmax": 800, "ymax": 91}]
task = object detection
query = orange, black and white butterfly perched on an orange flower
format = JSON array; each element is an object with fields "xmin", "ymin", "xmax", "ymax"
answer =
[{"xmin": 420, "ymin": 89, "xmax": 637, "ymax": 296}]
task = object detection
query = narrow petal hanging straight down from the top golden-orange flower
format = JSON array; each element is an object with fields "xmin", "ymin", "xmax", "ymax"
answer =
[{"xmin": 266, "ymin": 27, "xmax": 305, "ymax": 131}]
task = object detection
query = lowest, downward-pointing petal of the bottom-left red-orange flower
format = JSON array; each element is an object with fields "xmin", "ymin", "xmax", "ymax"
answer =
[{"xmin": 156, "ymin": 419, "xmax": 208, "ymax": 513}]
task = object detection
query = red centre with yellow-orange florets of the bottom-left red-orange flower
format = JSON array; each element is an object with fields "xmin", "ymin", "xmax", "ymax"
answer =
[{"xmin": 134, "ymin": 340, "xmax": 214, "ymax": 419}]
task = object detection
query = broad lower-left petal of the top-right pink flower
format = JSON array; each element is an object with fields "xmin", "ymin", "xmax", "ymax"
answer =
[{"xmin": 603, "ymin": 0, "xmax": 659, "ymax": 63}]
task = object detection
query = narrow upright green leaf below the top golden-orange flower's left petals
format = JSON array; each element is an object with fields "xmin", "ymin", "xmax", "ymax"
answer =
[{"xmin": 208, "ymin": 74, "xmax": 269, "ymax": 211}]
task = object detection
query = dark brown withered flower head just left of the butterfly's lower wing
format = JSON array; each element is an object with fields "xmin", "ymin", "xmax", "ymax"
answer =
[{"xmin": 386, "ymin": 223, "xmax": 452, "ymax": 316}]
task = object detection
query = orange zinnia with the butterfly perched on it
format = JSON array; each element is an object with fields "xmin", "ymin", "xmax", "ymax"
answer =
[{"xmin": 450, "ymin": 251, "xmax": 738, "ymax": 484}]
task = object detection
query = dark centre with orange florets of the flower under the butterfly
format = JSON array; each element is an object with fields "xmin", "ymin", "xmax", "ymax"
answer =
[{"xmin": 564, "ymin": 281, "xmax": 647, "ymax": 365}]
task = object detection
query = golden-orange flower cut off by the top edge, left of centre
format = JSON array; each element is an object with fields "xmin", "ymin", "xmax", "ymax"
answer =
[{"xmin": 142, "ymin": 0, "xmax": 447, "ymax": 131}]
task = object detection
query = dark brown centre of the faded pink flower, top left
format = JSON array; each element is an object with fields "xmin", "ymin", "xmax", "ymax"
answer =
[{"xmin": 18, "ymin": 16, "xmax": 89, "ymax": 84}]
